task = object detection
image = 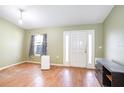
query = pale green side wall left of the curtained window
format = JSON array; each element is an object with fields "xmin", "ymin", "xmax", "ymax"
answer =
[{"xmin": 0, "ymin": 18, "xmax": 24, "ymax": 67}]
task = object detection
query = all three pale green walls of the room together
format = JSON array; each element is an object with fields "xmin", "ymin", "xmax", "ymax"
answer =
[{"xmin": 0, "ymin": 5, "xmax": 124, "ymax": 67}]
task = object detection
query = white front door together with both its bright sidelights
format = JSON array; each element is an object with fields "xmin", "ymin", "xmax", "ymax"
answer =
[{"xmin": 63, "ymin": 30, "xmax": 94, "ymax": 67}]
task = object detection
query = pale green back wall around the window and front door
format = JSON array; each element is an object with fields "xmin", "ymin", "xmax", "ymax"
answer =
[{"xmin": 24, "ymin": 24, "xmax": 103, "ymax": 64}]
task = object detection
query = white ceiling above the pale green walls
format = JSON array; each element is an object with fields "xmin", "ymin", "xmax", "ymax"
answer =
[{"xmin": 0, "ymin": 5, "xmax": 113, "ymax": 29}]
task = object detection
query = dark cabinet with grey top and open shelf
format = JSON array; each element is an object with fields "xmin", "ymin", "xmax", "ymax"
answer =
[{"xmin": 95, "ymin": 59, "xmax": 124, "ymax": 87}]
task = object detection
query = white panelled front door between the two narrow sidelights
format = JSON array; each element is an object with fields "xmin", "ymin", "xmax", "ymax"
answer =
[{"xmin": 70, "ymin": 31, "xmax": 87, "ymax": 67}]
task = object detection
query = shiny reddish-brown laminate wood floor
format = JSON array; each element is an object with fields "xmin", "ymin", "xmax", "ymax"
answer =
[{"xmin": 0, "ymin": 63, "xmax": 100, "ymax": 87}]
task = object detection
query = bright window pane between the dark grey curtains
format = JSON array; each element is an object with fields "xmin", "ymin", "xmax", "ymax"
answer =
[{"xmin": 34, "ymin": 35, "xmax": 43, "ymax": 56}]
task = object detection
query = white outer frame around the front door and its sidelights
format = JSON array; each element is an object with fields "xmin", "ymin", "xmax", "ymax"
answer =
[{"xmin": 63, "ymin": 30, "xmax": 95, "ymax": 68}]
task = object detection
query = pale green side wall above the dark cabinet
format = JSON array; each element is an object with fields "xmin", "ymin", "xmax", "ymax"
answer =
[{"xmin": 104, "ymin": 5, "xmax": 124, "ymax": 64}]
